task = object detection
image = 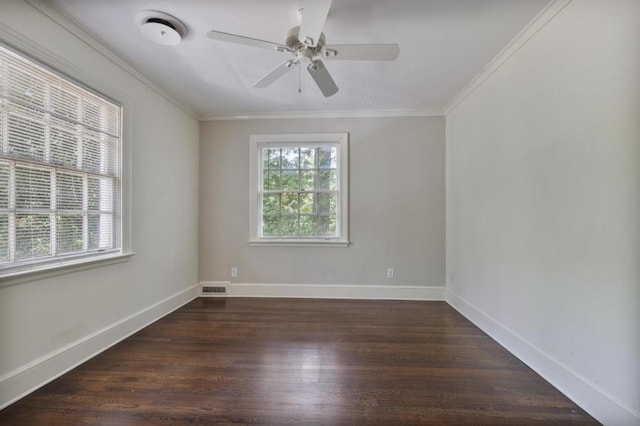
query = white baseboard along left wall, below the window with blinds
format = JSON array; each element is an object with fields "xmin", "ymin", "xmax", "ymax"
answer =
[{"xmin": 0, "ymin": 285, "xmax": 200, "ymax": 410}]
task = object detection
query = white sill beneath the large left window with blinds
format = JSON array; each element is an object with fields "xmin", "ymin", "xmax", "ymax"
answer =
[{"xmin": 0, "ymin": 252, "xmax": 135, "ymax": 287}]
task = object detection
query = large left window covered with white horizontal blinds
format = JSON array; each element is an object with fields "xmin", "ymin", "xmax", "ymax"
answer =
[{"xmin": 0, "ymin": 45, "xmax": 122, "ymax": 275}]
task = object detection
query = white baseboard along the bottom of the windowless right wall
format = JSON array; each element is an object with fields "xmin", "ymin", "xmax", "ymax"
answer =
[{"xmin": 446, "ymin": 289, "xmax": 640, "ymax": 426}]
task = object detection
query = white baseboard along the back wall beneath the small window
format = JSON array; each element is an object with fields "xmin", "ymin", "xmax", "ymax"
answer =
[{"xmin": 205, "ymin": 282, "xmax": 444, "ymax": 300}]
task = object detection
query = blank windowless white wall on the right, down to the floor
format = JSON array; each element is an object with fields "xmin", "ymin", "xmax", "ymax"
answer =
[{"xmin": 447, "ymin": 0, "xmax": 640, "ymax": 424}]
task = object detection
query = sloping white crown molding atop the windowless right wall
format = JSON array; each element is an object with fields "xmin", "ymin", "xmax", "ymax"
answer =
[{"xmin": 444, "ymin": 0, "xmax": 573, "ymax": 115}]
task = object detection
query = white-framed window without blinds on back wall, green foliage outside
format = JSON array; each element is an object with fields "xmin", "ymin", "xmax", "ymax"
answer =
[{"xmin": 250, "ymin": 133, "xmax": 348, "ymax": 246}]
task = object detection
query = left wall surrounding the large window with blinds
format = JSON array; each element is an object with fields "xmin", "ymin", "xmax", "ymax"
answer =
[{"xmin": 0, "ymin": 0, "xmax": 198, "ymax": 407}]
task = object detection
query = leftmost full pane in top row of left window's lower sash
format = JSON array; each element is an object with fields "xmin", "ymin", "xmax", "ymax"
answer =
[{"xmin": 16, "ymin": 165, "xmax": 51, "ymax": 209}]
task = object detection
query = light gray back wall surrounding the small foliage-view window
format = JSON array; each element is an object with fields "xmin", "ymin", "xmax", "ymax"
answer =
[{"xmin": 200, "ymin": 117, "xmax": 444, "ymax": 297}]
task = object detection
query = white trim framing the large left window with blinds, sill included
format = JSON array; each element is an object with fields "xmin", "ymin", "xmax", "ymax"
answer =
[{"xmin": 0, "ymin": 27, "xmax": 135, "ymax": 287}]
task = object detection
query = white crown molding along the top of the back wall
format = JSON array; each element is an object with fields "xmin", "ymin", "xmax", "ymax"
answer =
[{"xmin": 200, "ymin": 108, "xmax": 444, "ymax": 121}]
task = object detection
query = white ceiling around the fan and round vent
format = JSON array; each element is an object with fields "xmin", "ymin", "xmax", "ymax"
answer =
[{"xmin": 51, "ymin": 0, "xmax": 549, "ymax": 116}]
